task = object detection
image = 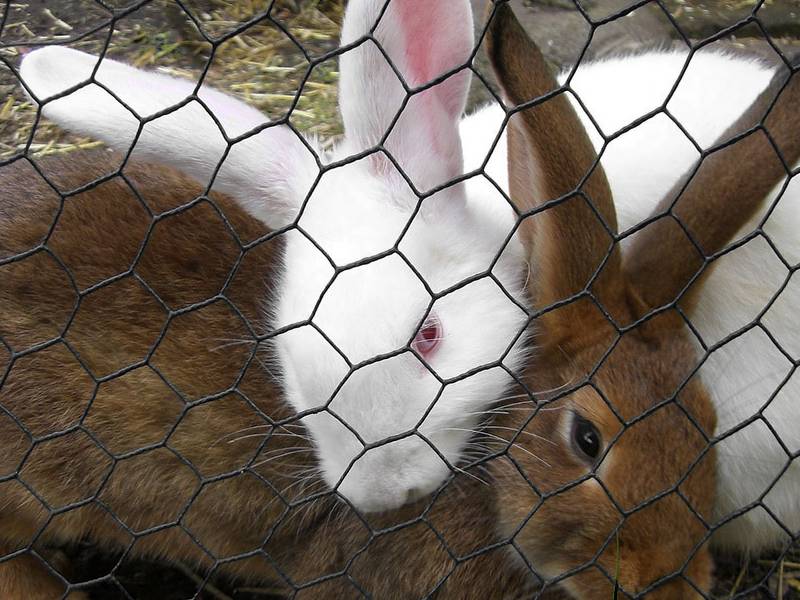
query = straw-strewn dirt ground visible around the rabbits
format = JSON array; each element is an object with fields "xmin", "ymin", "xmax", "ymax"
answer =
[{"xmin": 0, "ymin": 0, "xmax": 800, "ymax": 600}]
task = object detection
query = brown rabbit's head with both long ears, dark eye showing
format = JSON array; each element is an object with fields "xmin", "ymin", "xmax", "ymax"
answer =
[{"xmin": 487, "ymin": 3, "xmax": 800, "ymax": 599}]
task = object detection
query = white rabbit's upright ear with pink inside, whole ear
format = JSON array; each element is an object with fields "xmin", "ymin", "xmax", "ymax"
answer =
[{"xmin": 340, "ymin": 0, "xmax": 474, "ymax": 199}]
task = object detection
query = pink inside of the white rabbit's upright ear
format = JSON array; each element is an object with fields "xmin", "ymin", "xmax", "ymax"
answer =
[{"xmin": 364, "ymin": 0, "xmax": 473, "ymax": 191}]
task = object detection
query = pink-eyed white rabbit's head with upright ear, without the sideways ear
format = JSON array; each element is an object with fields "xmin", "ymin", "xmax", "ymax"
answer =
[{"xmin": 276, "ymin": 0, "xmax": 526, "ymax": 510}]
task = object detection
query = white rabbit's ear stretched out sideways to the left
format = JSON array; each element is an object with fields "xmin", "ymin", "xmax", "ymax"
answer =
[{"xmin": 20, "ymin": 46, "xmax": 318, "ymax": 229}]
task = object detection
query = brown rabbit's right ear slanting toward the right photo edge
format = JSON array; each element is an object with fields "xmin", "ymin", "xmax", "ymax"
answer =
[{"xmin": 625, "ymin": 63, "xmax": 800, "ymax": 309}]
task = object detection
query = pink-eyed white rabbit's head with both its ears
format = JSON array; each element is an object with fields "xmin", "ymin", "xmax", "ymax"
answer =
[{"xmin": 20, "ymin": 0, "xmax": 528, "ymax": 511}]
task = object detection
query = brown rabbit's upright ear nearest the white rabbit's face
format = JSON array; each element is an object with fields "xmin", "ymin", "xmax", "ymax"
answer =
[{"xmin": 486, "ymin": 3, "xmax": 619, "ymax": 330}]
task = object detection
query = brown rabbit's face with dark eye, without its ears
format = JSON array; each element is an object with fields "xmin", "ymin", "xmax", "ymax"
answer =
[{"xmin": 496, "ymin": 310, "xmax": 715, "ymax": 598}]
